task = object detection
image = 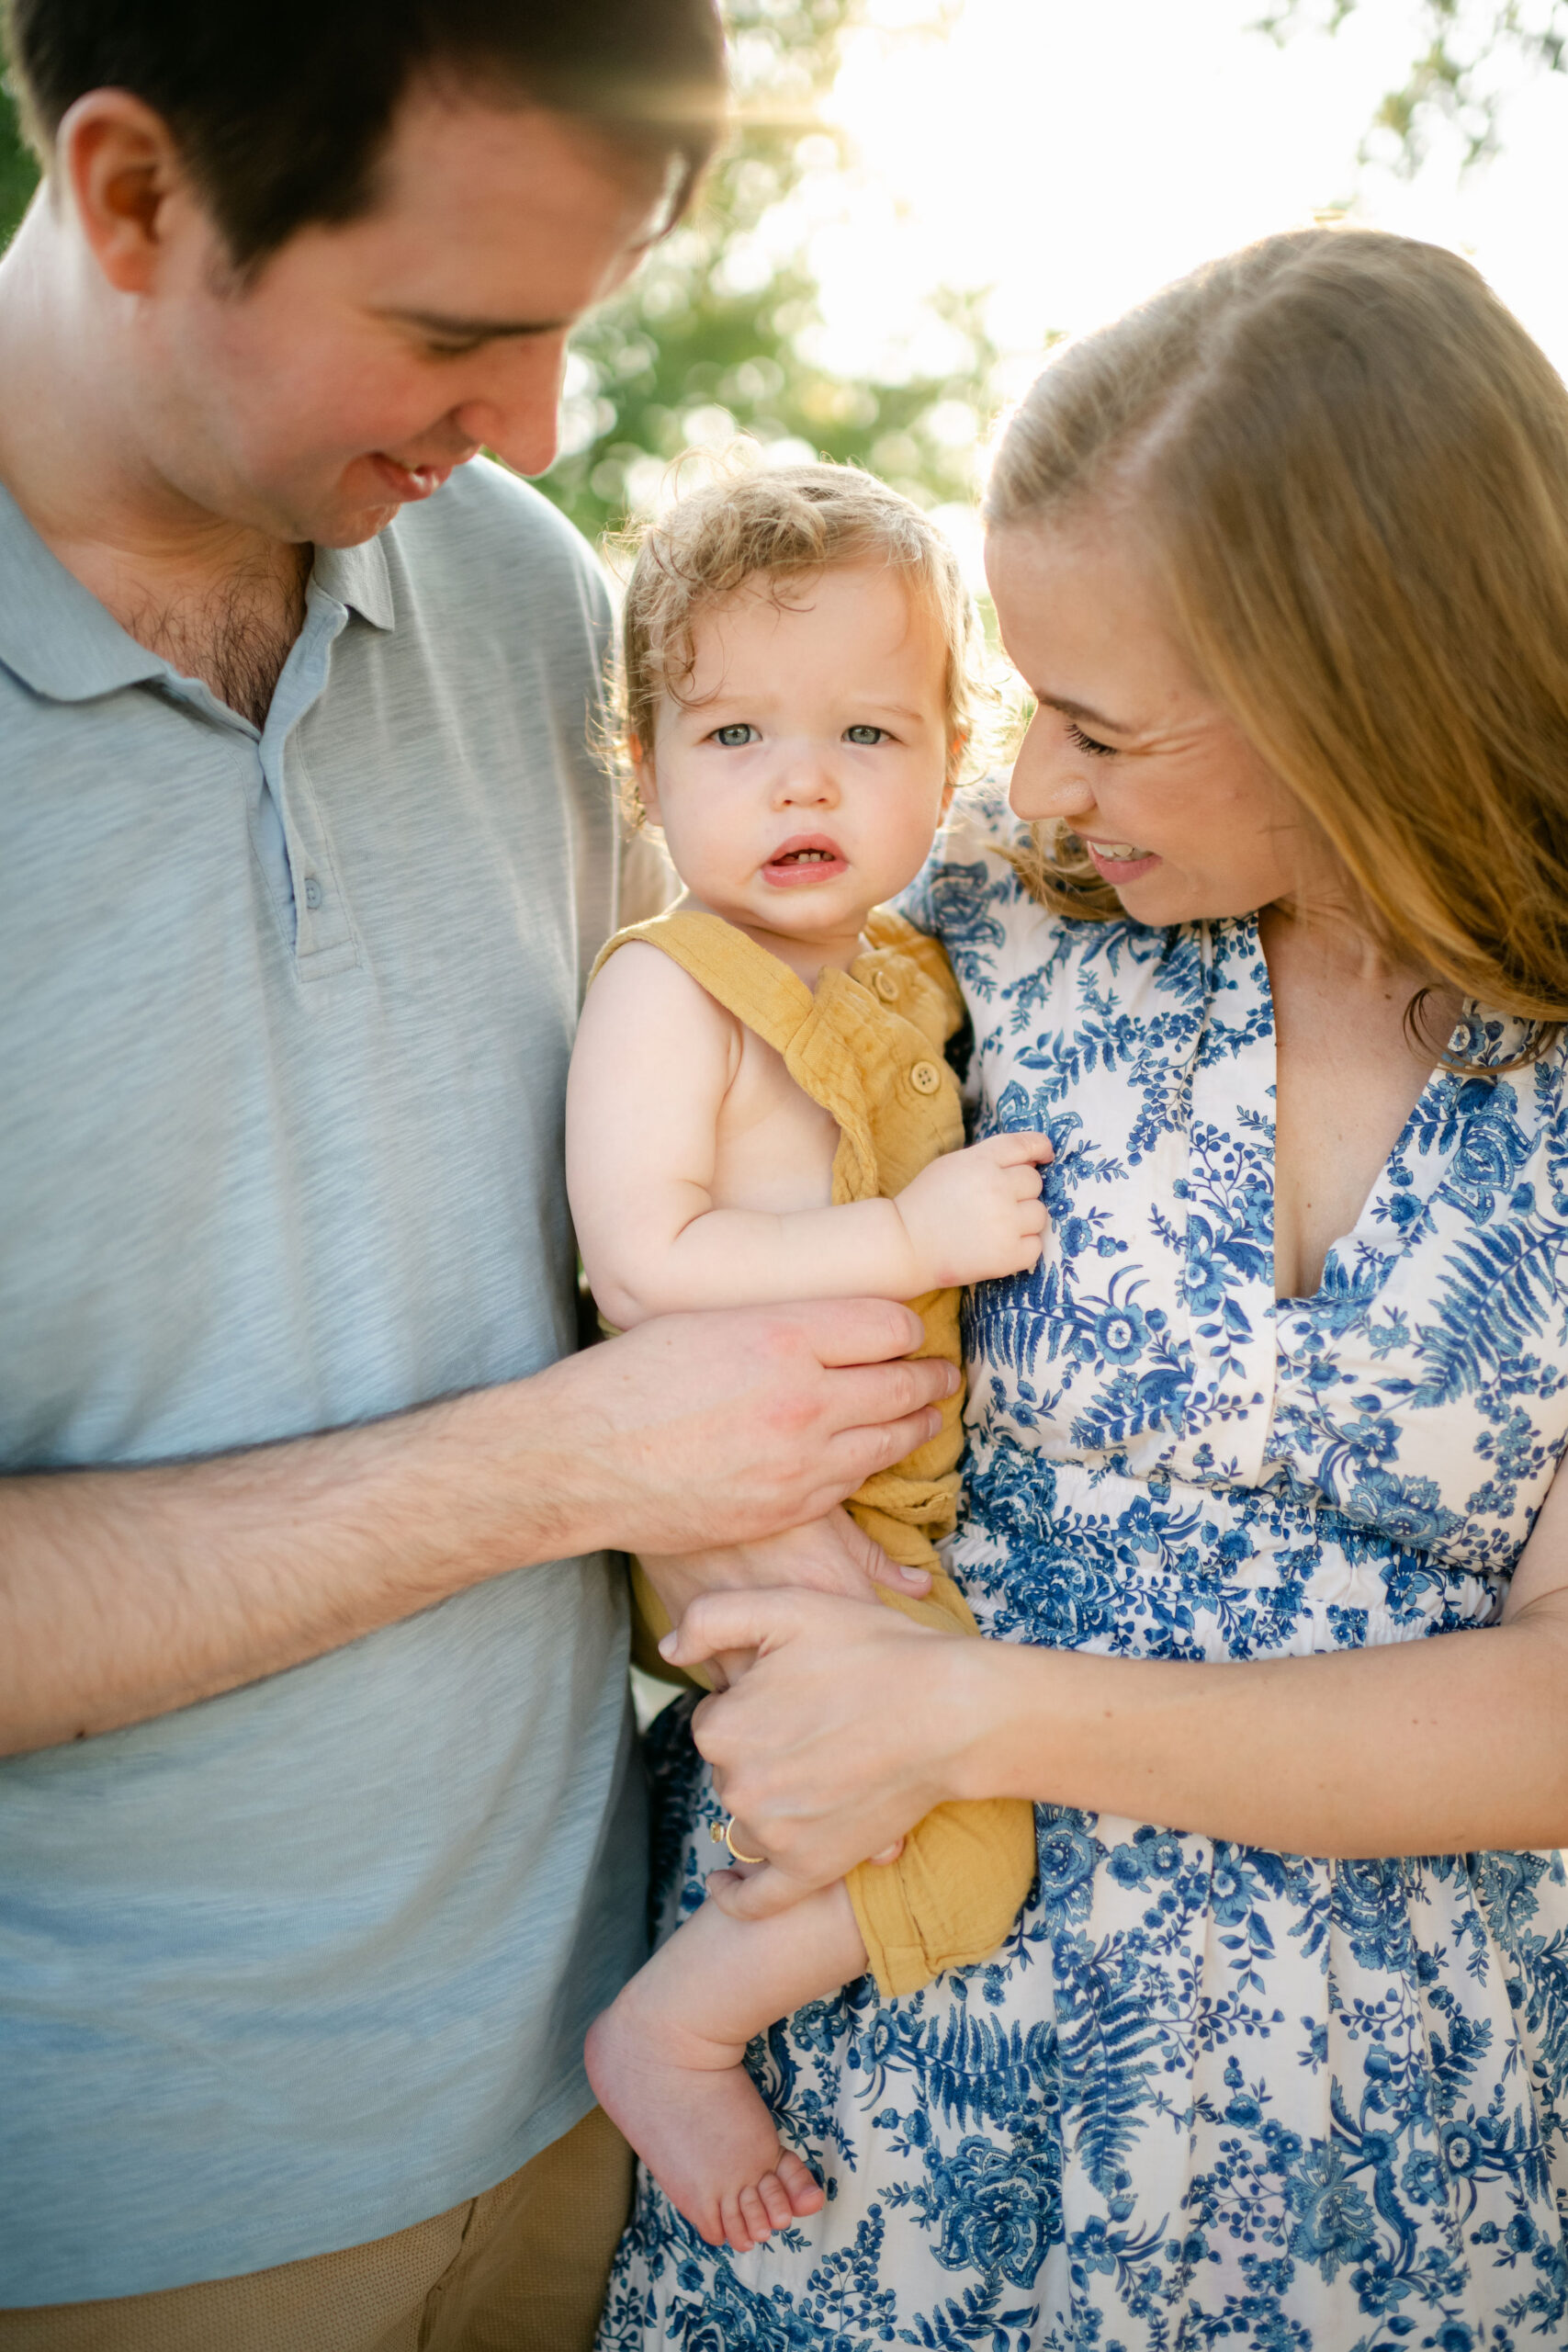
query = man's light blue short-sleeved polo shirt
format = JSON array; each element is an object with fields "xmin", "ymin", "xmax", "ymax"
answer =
[{"xmin": 0, "ymin": 463, "xmax": 644, "ymax": 2305}]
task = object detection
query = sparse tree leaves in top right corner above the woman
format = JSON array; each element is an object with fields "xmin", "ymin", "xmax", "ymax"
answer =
[{"xmin": 1258, "ymin": 0, "xmax": 1568, "ymax": 179}]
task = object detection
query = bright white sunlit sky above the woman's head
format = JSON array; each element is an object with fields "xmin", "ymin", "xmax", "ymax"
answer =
[{"xmin": 799, "ymin": 0, "xmax": 1568, "ymax": 395}]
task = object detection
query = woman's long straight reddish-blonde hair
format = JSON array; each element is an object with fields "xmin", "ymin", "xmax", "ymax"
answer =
[{"xmin": 985, "ymin": 228, "xmax": 1568, "ymax": 1058}]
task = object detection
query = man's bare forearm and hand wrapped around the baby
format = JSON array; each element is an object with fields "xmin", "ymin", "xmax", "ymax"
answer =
[{"xmin": 0, "ymin": 1301, "xmax": 957, "ymax": 1752}]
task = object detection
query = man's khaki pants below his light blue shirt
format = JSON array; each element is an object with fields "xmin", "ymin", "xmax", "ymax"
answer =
[{"xmin": 0, "ymin": 2108, "xmax": 632, "ymax": 2352}]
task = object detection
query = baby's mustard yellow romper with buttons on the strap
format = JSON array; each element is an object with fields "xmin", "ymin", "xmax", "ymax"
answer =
[{"xmin": 594, "ymin": 908, "xmax": 1034, "ymax": 1995}]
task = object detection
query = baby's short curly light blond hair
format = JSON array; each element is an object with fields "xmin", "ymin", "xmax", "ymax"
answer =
[{"xmin": 611, "ymin": 463, "xmax": 995, "ymax": 823}]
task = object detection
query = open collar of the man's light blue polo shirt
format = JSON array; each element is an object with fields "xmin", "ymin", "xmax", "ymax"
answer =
[{"xmin": 0, "ymin": 484, "xmax": 395, "ymax": 703}]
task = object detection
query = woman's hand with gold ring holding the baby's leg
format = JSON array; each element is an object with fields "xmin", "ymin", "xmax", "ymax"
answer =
[{"xmin": 660, "ymin": 1590, "xmax": 997, "ymax": 1919}]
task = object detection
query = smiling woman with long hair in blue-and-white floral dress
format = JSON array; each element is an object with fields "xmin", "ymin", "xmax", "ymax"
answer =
[{"xmin": 602, "ymin": 231, "xmax": 1568, "ymax": 2352}]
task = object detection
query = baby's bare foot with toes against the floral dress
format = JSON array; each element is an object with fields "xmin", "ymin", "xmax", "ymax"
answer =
[{"xmin": 585, "ymin": 1981, "xmax": 823, "ymax": 2253}]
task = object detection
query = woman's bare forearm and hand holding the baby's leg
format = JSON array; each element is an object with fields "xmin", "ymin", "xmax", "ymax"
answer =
[{"xmin": 668, "ymin": 1477, "xmax": 1568, "ymax": 1912}]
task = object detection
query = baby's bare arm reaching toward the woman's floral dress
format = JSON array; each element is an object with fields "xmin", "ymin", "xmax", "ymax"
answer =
[{"xmin": 567, "ymin": 941, "xmax": 1051, "ymax": 1329}]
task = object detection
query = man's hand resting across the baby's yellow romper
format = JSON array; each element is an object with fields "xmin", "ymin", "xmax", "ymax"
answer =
[{"xmin": 540, "ymin": 1298, "xmax": 959, "ymax": 1559}]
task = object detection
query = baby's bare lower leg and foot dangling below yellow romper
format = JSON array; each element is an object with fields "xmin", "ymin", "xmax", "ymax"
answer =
[{"xmin": 588, "ymin": 1872, "xmax": 865, "ymax": 2253}]
